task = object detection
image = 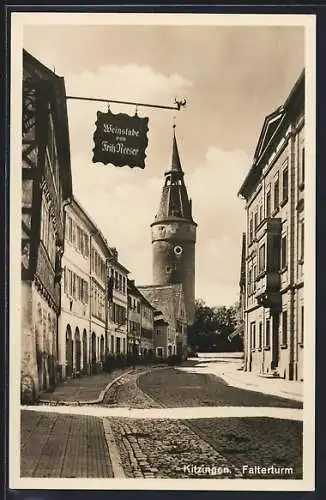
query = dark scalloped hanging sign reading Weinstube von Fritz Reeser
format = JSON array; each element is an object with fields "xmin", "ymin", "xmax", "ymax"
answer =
[{"xmin": 93, "ymin": 110, "xmax": 148, "ymax": 168}]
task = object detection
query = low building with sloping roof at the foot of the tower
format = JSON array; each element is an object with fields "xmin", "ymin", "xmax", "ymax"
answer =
[{"xmin": 138, "ymin": 284, "xmax": 188, "ymax": 358}]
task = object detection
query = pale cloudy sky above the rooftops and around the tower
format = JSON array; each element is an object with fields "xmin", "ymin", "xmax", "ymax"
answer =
[{"xmin": 24, "ymin": 17, "xmax": 304, "ymax": 306}]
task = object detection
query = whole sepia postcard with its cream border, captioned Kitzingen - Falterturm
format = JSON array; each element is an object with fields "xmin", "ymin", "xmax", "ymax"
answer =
[{"xmin": 9, "ymin": 12, "xmax": 316, "ymax": 491}]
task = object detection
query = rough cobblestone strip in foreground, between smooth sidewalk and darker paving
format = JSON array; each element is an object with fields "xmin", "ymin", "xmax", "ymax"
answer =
[{"xmin": 110, "ymin": 419, "xmax": 242, "ymax": 479}]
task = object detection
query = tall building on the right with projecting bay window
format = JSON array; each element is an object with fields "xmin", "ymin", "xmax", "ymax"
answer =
[{"xmin": 239, "ymin": 72, "xmax": 305, "ymax": 380}]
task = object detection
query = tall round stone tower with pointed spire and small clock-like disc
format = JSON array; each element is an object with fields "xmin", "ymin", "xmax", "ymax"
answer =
[{"xmin": 151, "ymin": 132, "xmax": 197, "ymax": 324}]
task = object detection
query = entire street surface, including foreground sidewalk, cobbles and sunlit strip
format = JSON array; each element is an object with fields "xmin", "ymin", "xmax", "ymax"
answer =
[{"xmin": 21, "ymin": 358, "xmax": 302, "ymax": 479}]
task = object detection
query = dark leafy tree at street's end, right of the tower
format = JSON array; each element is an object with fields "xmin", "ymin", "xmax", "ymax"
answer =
[{"xmin": 188, "ymin": 299, "xmax": 242, "ymax": 352}]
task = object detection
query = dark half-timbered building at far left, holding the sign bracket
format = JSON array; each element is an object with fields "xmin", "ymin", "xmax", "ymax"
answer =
[{"xmin": 21, "ymin": 51, "xmax": 72, "ymax": 402}]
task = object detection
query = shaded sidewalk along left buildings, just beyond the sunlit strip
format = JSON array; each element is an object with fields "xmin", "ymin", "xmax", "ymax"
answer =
[{"xmin": 39, "ymin": 368, "xmax": 127, "ymax": 403}]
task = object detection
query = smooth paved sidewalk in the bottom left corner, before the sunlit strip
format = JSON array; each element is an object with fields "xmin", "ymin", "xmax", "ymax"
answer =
[{"xmin": 21, "ymin": 409, "xmax": 113, "ymax": 478}]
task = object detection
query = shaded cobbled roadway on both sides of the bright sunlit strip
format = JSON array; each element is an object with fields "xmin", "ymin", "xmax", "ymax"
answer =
[{"xmin": 105, "ymin": 368, "xmax": 302, "ymax": 479}]
